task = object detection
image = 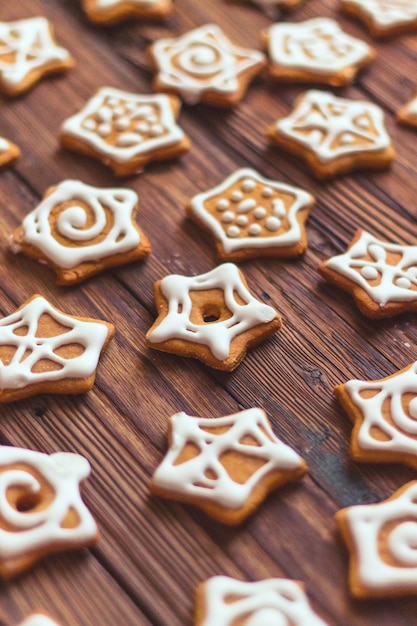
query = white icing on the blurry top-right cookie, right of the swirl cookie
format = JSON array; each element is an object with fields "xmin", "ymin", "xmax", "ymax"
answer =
[{"xmin": 267, "ymin": 17, "xmax": 370, "ymax": 75}]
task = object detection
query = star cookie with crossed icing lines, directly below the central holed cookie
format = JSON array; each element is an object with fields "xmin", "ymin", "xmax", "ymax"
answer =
[{"xmin": 150, "ymin": 408, "xmax": 307, "ymax": 524}]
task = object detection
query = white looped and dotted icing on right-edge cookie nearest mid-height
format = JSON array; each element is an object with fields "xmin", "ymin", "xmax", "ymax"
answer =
[{"xmin": 326, "ymin": 231, "xmax": 417, "ymax": 307}]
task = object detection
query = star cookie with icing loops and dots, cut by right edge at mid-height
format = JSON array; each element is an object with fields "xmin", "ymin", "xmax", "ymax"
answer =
[{"xmin": 318, "ymin": 230, "xmax": 417, "ymax": 319}]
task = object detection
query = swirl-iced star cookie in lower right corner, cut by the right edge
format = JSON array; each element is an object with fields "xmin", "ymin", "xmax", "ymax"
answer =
[{"xmin": 336, "ymin": 481, "xmax": 417, "ymax": 598}]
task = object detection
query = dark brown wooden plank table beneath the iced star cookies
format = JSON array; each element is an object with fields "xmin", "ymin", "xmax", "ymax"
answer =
[{"xmin": 0, "ymin": 0, "xmax": 417, "ymax": 626}]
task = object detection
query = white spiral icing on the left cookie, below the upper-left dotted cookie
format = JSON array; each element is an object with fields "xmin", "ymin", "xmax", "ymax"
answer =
[{"xmin": 18, "ymin": 180, "xmax": 140, "ymax": 269}]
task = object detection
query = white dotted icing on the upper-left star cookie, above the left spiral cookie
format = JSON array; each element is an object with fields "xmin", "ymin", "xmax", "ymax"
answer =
[{"xmin": 61, "ymin": 87, "xmax": 184, "ymax": 163}]
